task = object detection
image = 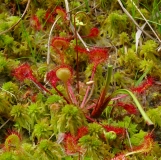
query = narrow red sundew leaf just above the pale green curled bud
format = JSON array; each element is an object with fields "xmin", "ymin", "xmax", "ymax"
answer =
[{"xmin": 103, "ymin": 125, "xmax": 126, "ymax": 135}]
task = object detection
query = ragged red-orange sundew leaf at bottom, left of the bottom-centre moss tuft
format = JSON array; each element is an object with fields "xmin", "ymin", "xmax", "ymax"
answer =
[{"xmin": 64, "ymin": 133, "xmax": 82, "ymax": 155}]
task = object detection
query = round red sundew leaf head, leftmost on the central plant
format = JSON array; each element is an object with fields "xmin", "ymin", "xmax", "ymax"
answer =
[{"xmin": 12, "ymin": 63, "xmax": 35, "ymax": 81}]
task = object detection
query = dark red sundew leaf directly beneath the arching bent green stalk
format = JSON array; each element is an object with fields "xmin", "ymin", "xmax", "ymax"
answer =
[{"xmin": 116, "ymin": 102, "xmax": 138, "ymax": 114}]
